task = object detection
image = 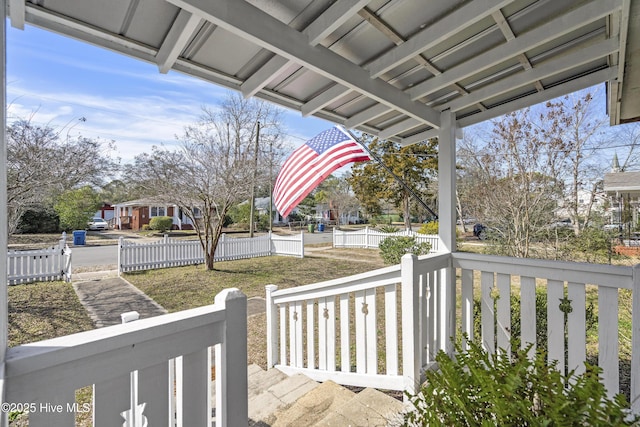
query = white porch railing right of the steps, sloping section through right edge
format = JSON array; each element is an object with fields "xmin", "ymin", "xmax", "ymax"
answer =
[{"xmin": 267, "ymin": 252, "xmax": 640, "ymax": 414}]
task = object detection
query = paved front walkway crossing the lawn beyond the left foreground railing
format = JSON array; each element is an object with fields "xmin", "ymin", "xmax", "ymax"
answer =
[{"xmin": 73, "ymin": 272, "xmax": 167, "ymax": 328}]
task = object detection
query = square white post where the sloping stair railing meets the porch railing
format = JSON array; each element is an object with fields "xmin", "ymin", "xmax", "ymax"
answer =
[{"xmin": 400, "ymin": 254, "xmax": 424, "ymax": 399}]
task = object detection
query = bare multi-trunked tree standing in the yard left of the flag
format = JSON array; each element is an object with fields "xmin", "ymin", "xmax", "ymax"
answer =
[{"xmin": 127, "ymin": 95, "xmax": 281, "ymax": 270}]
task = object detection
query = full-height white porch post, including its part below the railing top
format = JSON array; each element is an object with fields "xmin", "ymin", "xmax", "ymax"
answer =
[{"xmin": 432, "ymin": 110, "xmax": 456, "ymax": 355}]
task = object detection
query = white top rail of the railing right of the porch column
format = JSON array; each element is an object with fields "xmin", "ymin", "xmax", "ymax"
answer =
[{"xmin": 452, "ymin": 252, "xmax": 633, "ymax": 289}]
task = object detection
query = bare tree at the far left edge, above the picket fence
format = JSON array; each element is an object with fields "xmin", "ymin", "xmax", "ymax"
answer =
[{"xmin": 7, "ymin": 120, "xmax": 118, "ymax": 234}]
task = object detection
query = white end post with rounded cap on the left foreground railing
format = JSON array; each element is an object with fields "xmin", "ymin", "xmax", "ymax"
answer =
[{"xmin": 215, "ymin": 288, "xmax": 249, "ymax": 427}]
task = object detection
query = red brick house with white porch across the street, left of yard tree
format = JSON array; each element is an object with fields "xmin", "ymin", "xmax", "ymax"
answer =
[{"xmin": 114, "ymin": 198, "xmax": 199, "ymax": 231}]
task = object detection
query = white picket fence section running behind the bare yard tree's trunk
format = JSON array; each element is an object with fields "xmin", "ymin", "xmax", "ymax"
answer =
[{"xmin": 118, "ymin": 233, "xmax": 304, "ymax": 273}]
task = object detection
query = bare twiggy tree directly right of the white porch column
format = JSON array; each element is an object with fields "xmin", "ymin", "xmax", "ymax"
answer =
[{"xmin": 460, "ymin": 110, "xmax": 561, "ymax": 257}]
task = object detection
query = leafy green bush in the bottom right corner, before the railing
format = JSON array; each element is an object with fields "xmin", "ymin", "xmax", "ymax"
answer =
[{"xmin": 403, "ymin": 342, "xmax": 640, "ymax": 426}]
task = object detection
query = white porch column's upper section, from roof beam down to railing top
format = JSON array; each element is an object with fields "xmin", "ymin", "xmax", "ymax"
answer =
[{"xmin": 438, "ymin": 110, "xmax": 456, "ymax": 252}]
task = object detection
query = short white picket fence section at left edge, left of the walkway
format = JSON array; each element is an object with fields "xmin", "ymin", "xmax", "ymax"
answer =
[{"xmin": 7, "ymin": 233, "xmax": 71, "ymax": 285}]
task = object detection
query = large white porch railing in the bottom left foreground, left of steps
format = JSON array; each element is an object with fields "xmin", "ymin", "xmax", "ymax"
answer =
[{"xmin": 3, "ymin": 289, "xmax": 248, "ymax": 427}]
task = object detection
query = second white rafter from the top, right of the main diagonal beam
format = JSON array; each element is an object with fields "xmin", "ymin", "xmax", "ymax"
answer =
[{"xmin": 367, "ymin": 0, "xmax": 513, "ymax": 78}]
